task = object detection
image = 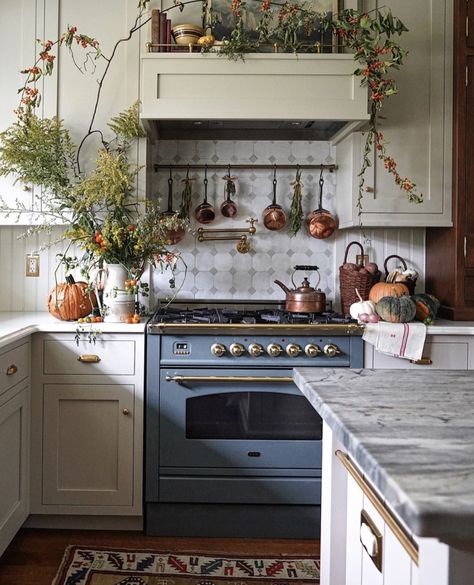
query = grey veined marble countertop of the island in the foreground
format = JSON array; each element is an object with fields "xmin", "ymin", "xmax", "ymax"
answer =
[{"xmin": 294, "ymin": 368, "xmax": 474, "ymax": 540}]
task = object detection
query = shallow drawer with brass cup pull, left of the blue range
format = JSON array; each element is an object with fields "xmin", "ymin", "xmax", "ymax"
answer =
[{"xmin": 43, "ymin": 339, "xmax": 135, "ymax": 376}]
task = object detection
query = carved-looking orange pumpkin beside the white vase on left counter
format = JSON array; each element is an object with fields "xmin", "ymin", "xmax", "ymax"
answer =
[{"xmin": 48, "ymin": 275, "xmax": 96, "ymax": 321}]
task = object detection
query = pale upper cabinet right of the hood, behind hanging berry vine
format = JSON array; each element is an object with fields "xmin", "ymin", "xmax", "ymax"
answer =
[{"xmin": 336, "ymin": 0, "xmax": 453, "ymax": 227}]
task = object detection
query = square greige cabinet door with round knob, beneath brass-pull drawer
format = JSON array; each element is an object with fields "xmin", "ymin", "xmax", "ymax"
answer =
[{"xmin": 42, "ymin": 384, "xmax": 134, "ymax": 509}]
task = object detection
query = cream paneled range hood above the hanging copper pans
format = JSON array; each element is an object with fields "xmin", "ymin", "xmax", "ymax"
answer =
[{"xmin": 141, "ymin": 53, "xmax": 369, "ymax": 142}]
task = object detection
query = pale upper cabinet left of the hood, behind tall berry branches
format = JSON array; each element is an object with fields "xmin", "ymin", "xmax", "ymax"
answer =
[{"xmin": 0, "ymin": 0, "xmax": 144, "ymax": 225}]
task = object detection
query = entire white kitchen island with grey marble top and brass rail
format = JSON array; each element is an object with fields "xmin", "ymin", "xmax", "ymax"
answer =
[{"xmin": 294, "ymin": 368, "xmax": 474, "ymax": 585}]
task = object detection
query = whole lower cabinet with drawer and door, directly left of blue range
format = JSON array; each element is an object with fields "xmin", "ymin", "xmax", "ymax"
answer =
[{"xmin": 31, "ymin": 334, "xmax": 144, "ymax": 516}]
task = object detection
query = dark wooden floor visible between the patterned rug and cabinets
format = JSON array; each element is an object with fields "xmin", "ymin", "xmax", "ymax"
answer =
[{"xmin": 0, "ymin": 528, "xmax": 319, "ymax": 585}]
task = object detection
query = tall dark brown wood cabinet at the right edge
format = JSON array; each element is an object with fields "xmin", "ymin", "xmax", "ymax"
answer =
[{"xmin": 426, "ymin": 0, "xmax": 474, "ymax": 321}]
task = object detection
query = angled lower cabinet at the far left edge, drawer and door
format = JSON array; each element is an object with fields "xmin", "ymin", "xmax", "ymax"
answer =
[{"xmin": 0, "ymin": 341, "xmax": 30, "ymax": 555}]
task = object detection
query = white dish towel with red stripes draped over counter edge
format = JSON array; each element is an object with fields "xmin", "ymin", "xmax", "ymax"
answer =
[{"xmin": 362, "ymin": 321, "xmax": 426, "ymax": 360}]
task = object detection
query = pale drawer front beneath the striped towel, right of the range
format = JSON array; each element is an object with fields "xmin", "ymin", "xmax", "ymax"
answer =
[{"xmin": 374, "ymin": 341, "xmax": 469, "ymax": 370}]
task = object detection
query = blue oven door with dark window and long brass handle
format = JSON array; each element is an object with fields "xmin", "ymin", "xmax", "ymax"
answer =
[{"xmin": 159, "ymin": 368, "xmax": 322, "ymax": 473}]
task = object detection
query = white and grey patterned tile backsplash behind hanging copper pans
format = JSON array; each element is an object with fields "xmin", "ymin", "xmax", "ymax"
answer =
[{"xmin": 150, "ymin": 141, "xmax": 424, "ymax": 301}]
